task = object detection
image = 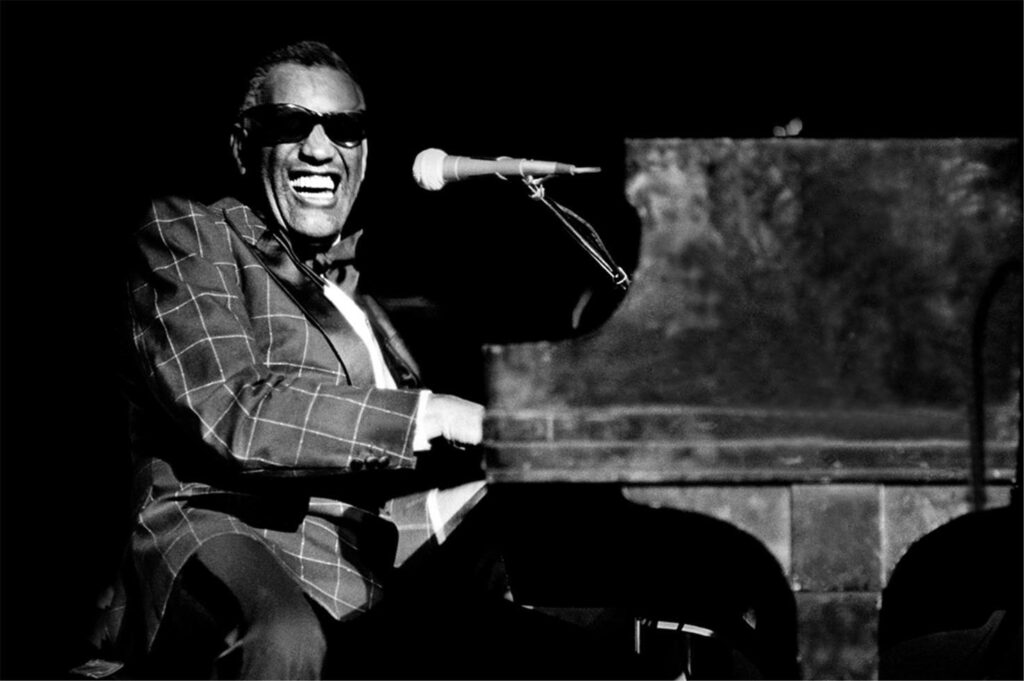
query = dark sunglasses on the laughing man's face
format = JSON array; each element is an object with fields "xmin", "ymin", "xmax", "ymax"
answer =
[{"xmin": 240, "ymin": 104, "xmax": 367, "ymax": 148}]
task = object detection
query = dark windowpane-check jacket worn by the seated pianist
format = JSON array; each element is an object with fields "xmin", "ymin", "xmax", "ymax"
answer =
[{"xmin": 121, "ymin": 199, "xmax": 434, "ymax": 645}]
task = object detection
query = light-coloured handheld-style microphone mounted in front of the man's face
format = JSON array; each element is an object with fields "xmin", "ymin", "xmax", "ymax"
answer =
[{"xmin": 413, "ymin": 148, "xmax": 601, "ymax": 191}]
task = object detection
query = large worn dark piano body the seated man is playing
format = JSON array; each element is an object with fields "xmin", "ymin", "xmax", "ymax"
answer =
[{"xmin": 475, "ymin": 139, "xmax": 1021, "ymax": 678}]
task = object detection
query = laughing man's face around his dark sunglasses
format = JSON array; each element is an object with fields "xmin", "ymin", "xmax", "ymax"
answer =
[{"xmin": 253, "ymin": 63, "xmax": 366, "ymax": 238}]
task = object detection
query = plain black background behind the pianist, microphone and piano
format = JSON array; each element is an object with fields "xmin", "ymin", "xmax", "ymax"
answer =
[{"xmin": 0, "ymin": 1, "xmax": 1024, "ymax": 678}]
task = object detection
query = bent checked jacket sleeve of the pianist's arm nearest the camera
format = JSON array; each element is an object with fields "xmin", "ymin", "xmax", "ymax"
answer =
[{"xmin": 128, "ymin": 196, "xmax": 419, "ymax": 475}]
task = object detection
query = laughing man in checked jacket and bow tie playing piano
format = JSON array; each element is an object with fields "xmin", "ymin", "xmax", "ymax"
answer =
[{"xmin": 112, "ymin": 43, "xmax": 618, "ymax": 679}]
